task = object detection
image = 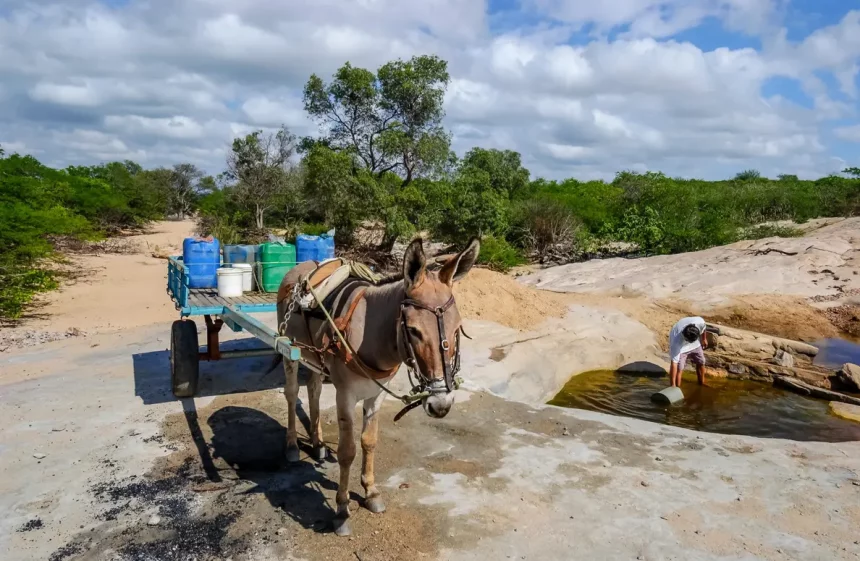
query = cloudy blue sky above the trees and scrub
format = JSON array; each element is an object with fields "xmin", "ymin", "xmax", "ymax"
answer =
[{"xmin": 0, "ymin": 0, "xmax": 860, "ymax": 180}]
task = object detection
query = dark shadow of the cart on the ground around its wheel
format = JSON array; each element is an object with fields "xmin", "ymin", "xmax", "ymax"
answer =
[{"xmin": 132, "ymin": 338, "xmax": 284, "ymax": 405}]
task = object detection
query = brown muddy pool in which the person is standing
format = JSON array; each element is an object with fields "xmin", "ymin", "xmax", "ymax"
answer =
[{"xmin": 549, "ymin": 370, "xmax": 860, "ymax": 442}]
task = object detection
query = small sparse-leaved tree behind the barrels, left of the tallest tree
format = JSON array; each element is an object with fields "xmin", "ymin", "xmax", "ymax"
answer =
[{"xmin": 225, "ymin": 127, "xmax": 298, "ymax": 229}]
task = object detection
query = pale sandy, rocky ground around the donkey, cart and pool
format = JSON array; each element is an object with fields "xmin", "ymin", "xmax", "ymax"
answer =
[{"xmin": 0, "ymin": 223, "xmax": 860, "ymax": 561}]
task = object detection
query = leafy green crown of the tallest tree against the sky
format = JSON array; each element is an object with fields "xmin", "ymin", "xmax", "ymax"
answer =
[{"xmin": 303, "ymin": 56, "xmax": 451, "ymax": 187}]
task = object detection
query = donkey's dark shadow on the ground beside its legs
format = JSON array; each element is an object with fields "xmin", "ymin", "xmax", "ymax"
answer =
[{"xmin": 204, "ymin": 405, "xmax": 358, "ymax": 532}]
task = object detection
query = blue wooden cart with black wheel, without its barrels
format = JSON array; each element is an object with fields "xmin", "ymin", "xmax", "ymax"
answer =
[{"xmin": 167, "ymin": 256, "xmax": 301, "ymax": 397}]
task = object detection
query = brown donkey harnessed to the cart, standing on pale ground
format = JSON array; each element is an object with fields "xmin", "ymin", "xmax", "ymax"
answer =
[{"xmin": 277, "ymin": 238, "xmax": 480, "ymax": 536}]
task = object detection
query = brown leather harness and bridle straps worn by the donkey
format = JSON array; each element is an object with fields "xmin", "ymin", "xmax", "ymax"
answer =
[{"xmin": 283, "ymin": 282, "xmax": 470, "ymax": 422}]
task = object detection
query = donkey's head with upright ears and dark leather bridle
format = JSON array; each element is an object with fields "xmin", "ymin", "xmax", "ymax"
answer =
[{"xmin": 400, "ymin": 238, "xmax": 481, "ymax": 418}]
